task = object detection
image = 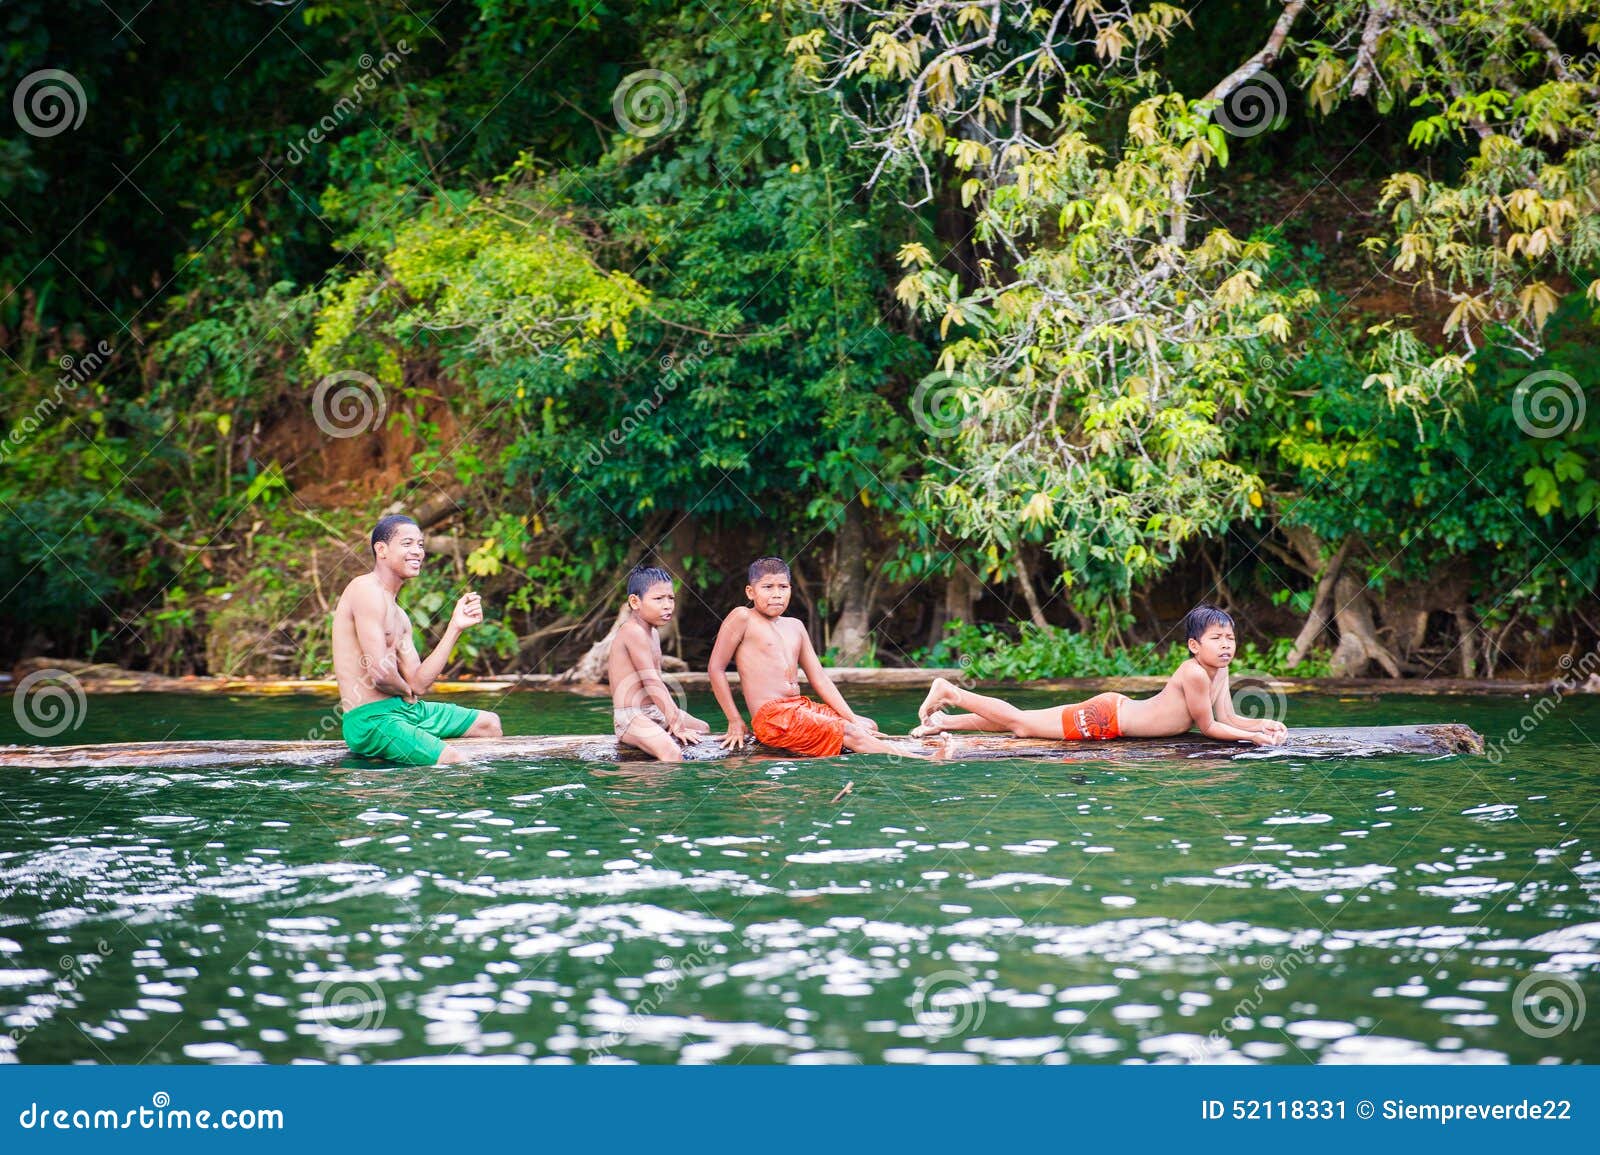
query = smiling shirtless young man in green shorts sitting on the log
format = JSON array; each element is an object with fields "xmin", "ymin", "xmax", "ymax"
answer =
[{"xmin": 333, "ymin": 514, "xmax": 501, "ymax": 766}]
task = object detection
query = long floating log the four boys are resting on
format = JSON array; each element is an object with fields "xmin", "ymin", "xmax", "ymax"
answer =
[{"xmin": 0, "ymin": 721, "xmax": 1483, "ymax": 769}]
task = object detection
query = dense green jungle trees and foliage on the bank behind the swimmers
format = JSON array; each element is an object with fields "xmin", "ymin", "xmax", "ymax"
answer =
[{"xmin": 0, "ymin": 0, "xmax": 1600, "ymax": 677}]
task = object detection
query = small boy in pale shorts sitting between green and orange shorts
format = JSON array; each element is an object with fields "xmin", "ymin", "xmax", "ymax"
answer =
[{"xmin": 606, "ymin": 566, "xmax": 710, "ymax": 761}]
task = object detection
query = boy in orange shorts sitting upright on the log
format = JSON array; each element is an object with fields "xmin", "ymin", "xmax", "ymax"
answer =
[{"xmin": 707, "ymin": 557, "xmax": 922, "ymax": 758}]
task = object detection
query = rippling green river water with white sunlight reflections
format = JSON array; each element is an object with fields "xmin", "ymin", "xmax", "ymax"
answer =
[{"xmin": 0, "ymin": 693, "xmax": 1600, "ymax": 1064}]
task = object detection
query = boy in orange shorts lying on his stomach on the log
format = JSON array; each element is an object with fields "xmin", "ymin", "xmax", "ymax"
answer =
[{"xmin": 910, "ymin": 605, "xmax": 1288, "ymax": 745}]
